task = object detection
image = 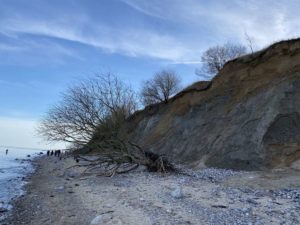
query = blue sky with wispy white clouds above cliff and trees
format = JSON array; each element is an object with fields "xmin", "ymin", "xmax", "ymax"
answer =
[{"xmin": 0, "ymin": 0, "xmax": 300, "ymax": 148}]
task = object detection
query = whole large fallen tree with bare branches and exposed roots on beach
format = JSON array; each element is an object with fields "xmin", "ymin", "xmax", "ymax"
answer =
[{"xmin": 39, "ymin": 73, "xmax": 173, "ymax": 176}]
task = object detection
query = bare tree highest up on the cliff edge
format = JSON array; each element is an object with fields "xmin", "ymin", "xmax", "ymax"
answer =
[{"xmin": 196, "ymin": 43, "xmax": 247, "ymax": 77}]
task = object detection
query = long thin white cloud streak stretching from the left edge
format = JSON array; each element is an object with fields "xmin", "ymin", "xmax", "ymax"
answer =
[{"xmin": 2, "ymin": 17, "xmax": 195, "ymax": 60}]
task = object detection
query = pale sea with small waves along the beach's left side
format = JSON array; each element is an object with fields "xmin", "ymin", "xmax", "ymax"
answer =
[{"xmin": 0, "ymin": 147, "xmax": 45, "ymax": 221}]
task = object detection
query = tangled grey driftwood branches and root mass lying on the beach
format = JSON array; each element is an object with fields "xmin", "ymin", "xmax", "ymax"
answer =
[{"xmin": 73, "ymin": 138, "xmax": 175, "ymax": 177}]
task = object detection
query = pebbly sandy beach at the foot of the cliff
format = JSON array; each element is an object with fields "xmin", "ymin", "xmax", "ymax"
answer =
[{"xmin": 3, "ymin": 157, "xmax": 300, "ymax": 225}]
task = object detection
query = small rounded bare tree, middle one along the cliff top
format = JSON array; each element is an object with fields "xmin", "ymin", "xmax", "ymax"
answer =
[{"xmin": 141, "ymin": 70, "xmax": 180, "ymax": 105}]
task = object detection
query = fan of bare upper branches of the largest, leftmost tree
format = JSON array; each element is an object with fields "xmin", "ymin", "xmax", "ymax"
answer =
[{"xmin": 38, "ymin": 73, "xmax": 137, "ymax": 145}]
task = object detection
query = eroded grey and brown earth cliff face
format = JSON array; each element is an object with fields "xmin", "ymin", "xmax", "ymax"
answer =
[{"xmin": 124, "ymin": 39, "xmax": 300, "ymax": 170}]
